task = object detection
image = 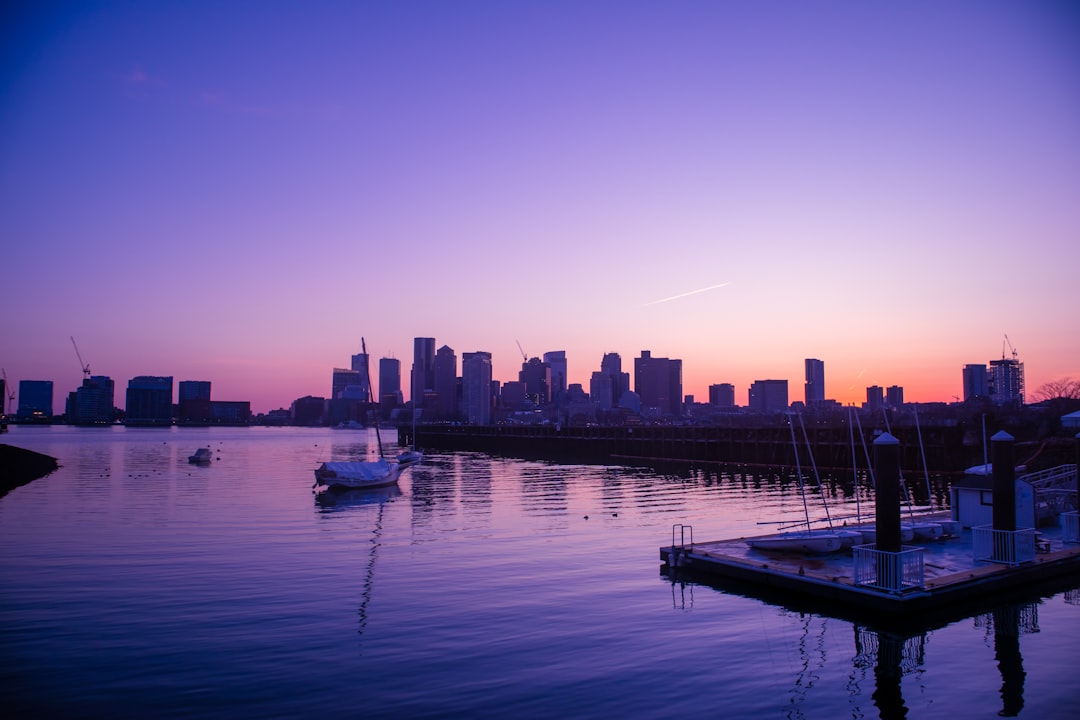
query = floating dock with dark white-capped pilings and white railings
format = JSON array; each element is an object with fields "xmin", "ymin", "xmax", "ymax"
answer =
[{"xmin": 660, "ymin": 431, "xmax": 1080, "ymax": 616}]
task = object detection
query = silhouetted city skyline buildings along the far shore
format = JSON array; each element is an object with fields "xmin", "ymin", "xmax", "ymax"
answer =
[{"xmin": 3, "ymin": 337, "xmax": 1025, "ymax": 426}]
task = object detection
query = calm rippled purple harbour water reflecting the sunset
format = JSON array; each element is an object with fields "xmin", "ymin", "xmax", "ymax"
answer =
[{"xmin": 0, "ymin": 427, "xmax": 1080, "ymax": 719}]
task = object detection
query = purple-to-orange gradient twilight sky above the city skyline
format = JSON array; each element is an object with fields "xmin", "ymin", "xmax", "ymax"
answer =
[{"xmin": 0, "ymin": 0, "xmax": 1080, "ymax": 412}]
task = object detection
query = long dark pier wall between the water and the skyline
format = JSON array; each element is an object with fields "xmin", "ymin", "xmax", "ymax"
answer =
[{"xmin": 408, "ymin": 422, "xmax": 983, "ymax": 473}]
